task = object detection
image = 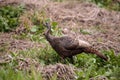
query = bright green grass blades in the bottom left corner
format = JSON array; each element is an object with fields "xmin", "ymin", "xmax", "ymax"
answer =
[{"xmin": 0, "ymin": 67, "xmax": 43, "ymax": 80}]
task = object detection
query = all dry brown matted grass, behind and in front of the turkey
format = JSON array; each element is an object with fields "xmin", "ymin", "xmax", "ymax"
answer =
[{"xmin": 0, "ymin": 0, "xmax": 120, "ymax": 80}]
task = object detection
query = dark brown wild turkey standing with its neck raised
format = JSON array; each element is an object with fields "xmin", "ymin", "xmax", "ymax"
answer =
[{"xmin": 44, "ymin": 23, "xmax": 107, "ymax": 61}]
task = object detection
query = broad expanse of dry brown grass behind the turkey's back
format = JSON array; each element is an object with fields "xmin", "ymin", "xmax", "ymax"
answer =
[{"xmin": 0, "ymin": 0, "xmax": 120, "ymax": 53}]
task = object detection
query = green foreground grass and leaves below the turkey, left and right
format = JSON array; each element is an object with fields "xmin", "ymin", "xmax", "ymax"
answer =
[{"xmin": 0, "ymin": 45, "xmax": 120, "ymax": 80}]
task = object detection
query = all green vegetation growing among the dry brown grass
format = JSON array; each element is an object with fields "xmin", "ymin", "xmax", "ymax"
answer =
[{"xmin": 0, "ymin": 0, "xmax": 120, "ymax": 80}]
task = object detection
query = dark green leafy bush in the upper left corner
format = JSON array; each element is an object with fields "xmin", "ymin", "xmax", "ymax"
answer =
[{"xmin": 0, "ymin": 5, "xmax": 24, "ymax": 32}]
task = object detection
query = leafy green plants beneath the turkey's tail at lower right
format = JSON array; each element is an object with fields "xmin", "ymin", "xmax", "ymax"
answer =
[{"xmin": 75, "ymin": 50, "xmax": 120, "ymax": 80}]
